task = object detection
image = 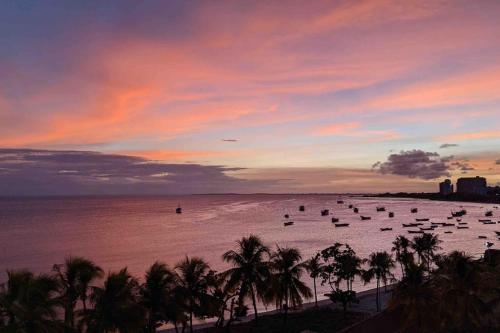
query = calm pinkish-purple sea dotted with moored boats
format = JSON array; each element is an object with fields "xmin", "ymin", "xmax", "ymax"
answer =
[{"xmin": 0, "ymin": 195, "xmax": 500, "ymax": 306}]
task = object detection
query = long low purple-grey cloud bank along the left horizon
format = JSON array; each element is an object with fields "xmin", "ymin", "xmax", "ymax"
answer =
[{"xmin": 0, "ymin": 149, "xmax": 276, "ymax": 196}]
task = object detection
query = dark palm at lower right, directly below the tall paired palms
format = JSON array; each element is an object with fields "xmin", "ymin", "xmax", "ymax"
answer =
[{"xmin": 388, "ymin": 262, "xmax": 437, "ymax": 332}]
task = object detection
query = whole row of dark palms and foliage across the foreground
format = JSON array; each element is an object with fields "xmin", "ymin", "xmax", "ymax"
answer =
[{"xmin": 0, "ymin": 234, "xmax": 500, "ymax": 333}]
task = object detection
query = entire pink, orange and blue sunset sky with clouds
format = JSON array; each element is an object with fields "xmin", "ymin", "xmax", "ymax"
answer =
[{"xmin": 0, "ymin": 0, "xmax": 500, "ymax": 195}]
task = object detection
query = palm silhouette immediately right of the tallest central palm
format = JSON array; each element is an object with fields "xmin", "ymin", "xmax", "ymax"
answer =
[{"xmin": 268, "ymin": 246, "xmax": 312, "ymax": 324}]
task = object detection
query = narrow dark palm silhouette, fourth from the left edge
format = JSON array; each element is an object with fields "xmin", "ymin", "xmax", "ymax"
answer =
[{"xmin": 141, "ymin": 262, "xmax": 176, "ymax": 333}]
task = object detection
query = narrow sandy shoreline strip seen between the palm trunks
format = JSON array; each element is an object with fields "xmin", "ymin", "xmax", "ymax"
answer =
[{"xmin": 158, "ymin": 284, "xmax": 395, "ymax": 333}]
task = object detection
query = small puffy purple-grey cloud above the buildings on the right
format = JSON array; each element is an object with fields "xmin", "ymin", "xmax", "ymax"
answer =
[{"xmin": 372, "ymin": 149, "xmax": 453, "ymax": 179}]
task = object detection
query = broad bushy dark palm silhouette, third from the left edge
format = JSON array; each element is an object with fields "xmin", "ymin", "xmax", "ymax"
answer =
[{"xmin": 80, "ymin": 268, "xmax": 146, "ymax": 333}]
